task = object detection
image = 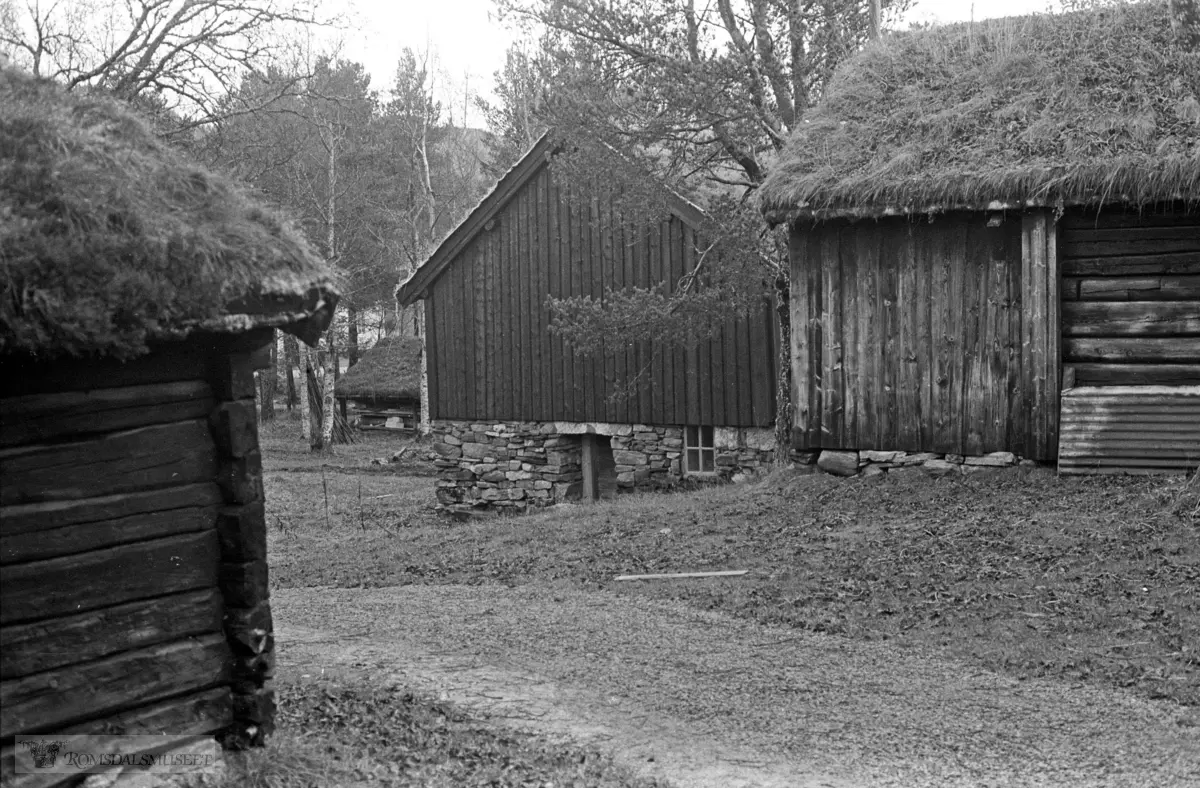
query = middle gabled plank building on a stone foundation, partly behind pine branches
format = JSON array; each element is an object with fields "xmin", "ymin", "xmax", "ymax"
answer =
[{"xmin": 397, "ymin": 136, "xmax": 778, "ymax": 511}]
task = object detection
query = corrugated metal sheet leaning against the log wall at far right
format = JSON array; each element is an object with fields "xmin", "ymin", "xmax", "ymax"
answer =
[{"xmin": 1058, "ymin": 386, "xmax": 1200, "ymax": 474}]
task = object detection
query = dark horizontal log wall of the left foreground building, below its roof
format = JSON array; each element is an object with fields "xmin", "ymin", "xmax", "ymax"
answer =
[{"xmin": 0, "ymin": 345, "xmax": 233, "ymax": 784}]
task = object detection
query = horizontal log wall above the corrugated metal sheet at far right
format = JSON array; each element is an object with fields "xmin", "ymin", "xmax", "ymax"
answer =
[{"xmin": 1060, "ymin": 206, "xmax": 1200, "ymax": 385}]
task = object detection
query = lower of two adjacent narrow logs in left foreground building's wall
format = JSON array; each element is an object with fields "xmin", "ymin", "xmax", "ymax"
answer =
[{"xmin": 0, "ymin": 506, "xmax": 217, "ymax": 566}]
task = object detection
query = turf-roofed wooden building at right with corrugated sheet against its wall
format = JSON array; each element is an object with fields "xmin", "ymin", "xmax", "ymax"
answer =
[{"xmin": 760, "ymin": 2, "xmax": 1200, "ymax": 473}]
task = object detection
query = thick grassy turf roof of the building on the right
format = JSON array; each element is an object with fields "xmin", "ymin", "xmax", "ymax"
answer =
[{"xmin": 760, "ymin": 2, "xmax": 1200, "ymax": 221}]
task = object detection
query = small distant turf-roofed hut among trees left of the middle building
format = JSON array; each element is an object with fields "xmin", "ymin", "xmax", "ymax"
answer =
[{"xmin": 335, "ymin": 337, "xmax": 425, "ymax": 432}]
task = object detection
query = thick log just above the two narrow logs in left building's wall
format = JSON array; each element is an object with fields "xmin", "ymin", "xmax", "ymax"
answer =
[{"xmin": 0, "ymin": 420, "xmax": 216, "ymax": 506}]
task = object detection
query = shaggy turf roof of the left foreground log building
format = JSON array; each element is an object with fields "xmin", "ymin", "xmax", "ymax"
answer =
[{"xmin": 0, "ymin": 68, "xmax": 337, "ymax": 359}]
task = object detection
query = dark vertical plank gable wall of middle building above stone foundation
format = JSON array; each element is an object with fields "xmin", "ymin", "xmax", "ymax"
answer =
[{"xmin": 426, "ymin": 161, "xmax": 778, "ymax": 427}]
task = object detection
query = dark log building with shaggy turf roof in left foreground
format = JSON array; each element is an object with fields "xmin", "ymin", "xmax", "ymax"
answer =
[{"xmin": 0, "ymin": 64, "xmax": 336, "ymax": 786}]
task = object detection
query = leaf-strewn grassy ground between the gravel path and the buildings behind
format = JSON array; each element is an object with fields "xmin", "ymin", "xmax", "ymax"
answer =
[{"xmin": 264, "ymin": 417, "xmax": 1200, "ymax": 706}]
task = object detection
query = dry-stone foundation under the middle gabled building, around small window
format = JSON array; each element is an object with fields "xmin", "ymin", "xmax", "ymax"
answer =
[{"xmin": 431, "ymin": 421, "xmax": 774, "ymax": 513}]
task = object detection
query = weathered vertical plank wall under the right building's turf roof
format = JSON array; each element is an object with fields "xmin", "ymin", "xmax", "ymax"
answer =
[{"xmin": 791, "ymin": 212, "xmax": 1058, "ymax": 459}]
